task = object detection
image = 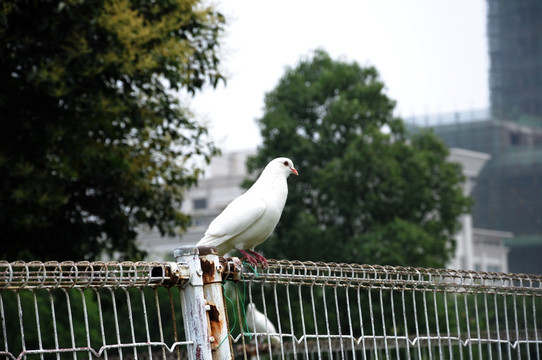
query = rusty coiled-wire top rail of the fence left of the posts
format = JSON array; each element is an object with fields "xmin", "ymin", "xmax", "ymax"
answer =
[{"xmin": 0, "ymin": 261, "xmax": 188, "ymax": 290}]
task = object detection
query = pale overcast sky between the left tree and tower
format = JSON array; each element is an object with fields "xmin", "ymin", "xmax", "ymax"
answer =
[{"xmin": 191, "ymin": 0, "xmax": 489, "ymax": 151}]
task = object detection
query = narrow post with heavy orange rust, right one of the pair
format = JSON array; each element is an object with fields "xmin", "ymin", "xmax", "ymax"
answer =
[{"xmin": 198, "ymin": 247, "xmax": 233, "ymax": 360}]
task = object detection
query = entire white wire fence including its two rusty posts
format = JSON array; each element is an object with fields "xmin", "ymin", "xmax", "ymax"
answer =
[{"xmin": 0, "ymin": 249, "xmax": 542, "ymax": 360}]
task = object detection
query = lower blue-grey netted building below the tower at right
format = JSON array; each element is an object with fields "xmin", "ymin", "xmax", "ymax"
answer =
[{"xmin": 405, "ymin": 108, "xmax": 542, "ymax": 274}]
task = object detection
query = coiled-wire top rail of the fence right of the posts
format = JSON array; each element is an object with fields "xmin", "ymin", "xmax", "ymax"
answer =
[{"xmin": 242, "ymin": 260, "xmax": 542, "ymax": 296}]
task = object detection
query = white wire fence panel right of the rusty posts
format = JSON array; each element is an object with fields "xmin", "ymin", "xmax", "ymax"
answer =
[{"xmin": 232, "ymin": 261, "xmax": 542, "ymax": 359}]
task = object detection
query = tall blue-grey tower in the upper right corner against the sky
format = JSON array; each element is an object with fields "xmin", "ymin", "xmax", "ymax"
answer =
[{"xmin": 487, "ymin": 0, "xmax": 542, "ymax": 119}]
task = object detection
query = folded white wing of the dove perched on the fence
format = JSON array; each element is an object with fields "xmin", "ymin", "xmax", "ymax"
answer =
[{"xmin": 198, "ymin": 193, "xmax": 266, "ymax": 246}]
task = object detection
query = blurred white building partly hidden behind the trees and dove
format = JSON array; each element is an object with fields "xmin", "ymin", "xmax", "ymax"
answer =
[{"xmin": 138, "ymin": 149, "xmax": 512, "ymax": 272}]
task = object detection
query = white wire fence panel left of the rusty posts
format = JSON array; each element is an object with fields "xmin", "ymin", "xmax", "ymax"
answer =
[{"xmin": 0, "ymin": 262, "xmax": 190, "ymax": 360}]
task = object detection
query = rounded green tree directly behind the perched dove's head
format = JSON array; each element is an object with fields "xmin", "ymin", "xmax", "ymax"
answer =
[{"xmin": 248, "ymin": 50, "xmax": 471, "ymax": 266}]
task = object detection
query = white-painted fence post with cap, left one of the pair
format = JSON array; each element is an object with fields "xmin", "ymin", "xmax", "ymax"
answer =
[{"xmin": 173, "ymin": 245, "xmax": 212, "ymax": 360}]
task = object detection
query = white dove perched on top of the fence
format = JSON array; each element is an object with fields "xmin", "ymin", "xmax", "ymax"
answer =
[{"xmin": 196, "ymin": 157, "xmax": 298, "ymax": 266}]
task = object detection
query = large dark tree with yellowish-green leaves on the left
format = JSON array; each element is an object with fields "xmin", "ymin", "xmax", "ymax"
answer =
[{"xmin": 0, "ymin": 0, "xmax": 224, "ymax": 260}]
